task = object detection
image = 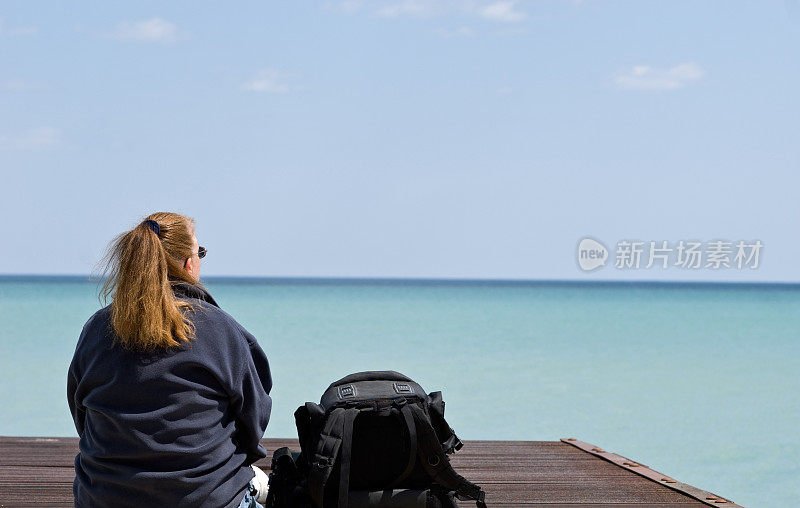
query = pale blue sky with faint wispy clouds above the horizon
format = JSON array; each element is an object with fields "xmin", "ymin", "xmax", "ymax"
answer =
[{"xmin": 0, "ymin": 0, "xmax": 800, "ymax": 282}]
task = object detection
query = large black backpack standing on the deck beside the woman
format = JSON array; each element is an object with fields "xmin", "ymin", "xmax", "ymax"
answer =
[{"xmin": 267, "ymin": 371, "xmax": 486, "ymax": 508}]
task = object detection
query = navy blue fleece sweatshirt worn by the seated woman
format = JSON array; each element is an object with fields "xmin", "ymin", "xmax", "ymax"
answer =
[{"xmin": 67, "ymin": 284, "xmax": 272, "ymax": 507}]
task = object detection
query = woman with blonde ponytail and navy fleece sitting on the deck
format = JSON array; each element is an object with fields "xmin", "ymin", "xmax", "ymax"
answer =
[{"xmin": 67, "ymin": 212, "xmax": 272, "ymax": 507}]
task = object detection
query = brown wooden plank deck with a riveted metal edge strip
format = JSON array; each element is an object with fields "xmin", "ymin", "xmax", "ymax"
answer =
[{"xmin": 0, "ymin": 437, "xmax": 738, "ymax": 508}]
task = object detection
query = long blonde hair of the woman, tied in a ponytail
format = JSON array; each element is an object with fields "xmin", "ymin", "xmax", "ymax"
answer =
[{"xmin": 100, "ymin": 212, "xmax": 198, "ymax": 351}]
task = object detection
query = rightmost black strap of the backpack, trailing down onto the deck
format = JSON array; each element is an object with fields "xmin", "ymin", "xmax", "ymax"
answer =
[{"xmin": 410, "ymin": 404, "xmax": 486, "ymax": 508}]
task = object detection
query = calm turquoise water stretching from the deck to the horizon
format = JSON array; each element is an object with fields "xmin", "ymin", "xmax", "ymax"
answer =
[{"xmin": 0, "ymin": 278, "xmax": 800, "ymax": 506}]
